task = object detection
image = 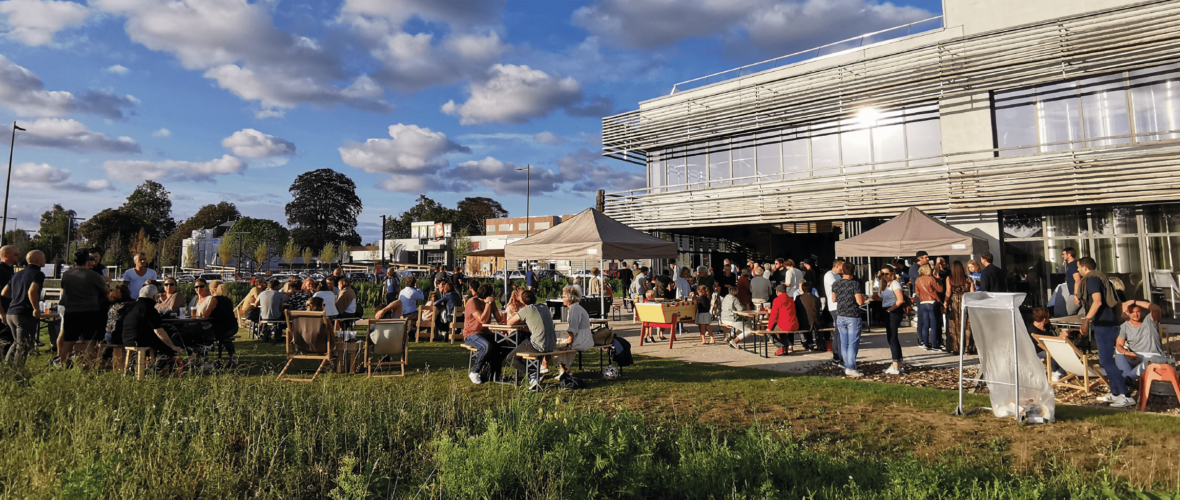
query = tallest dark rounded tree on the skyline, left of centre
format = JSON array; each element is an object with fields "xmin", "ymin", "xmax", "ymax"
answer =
[{"xmin": 286, "ymin": 169, "xmax": 362, "ymax": 252}]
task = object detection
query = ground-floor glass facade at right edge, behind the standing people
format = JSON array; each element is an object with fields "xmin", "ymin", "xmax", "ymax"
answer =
[{"xmin": 1001, "ymin": 204, "xmax": 1180, "ymax": 315}]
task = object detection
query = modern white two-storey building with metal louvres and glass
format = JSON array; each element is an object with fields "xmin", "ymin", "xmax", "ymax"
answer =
[{"xmin": 603, "ymin": 0, "xmax": 1180, "ymax": 314}]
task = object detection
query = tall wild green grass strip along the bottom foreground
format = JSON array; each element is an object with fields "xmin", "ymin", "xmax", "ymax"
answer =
[{"xmin": 0, "ymin": 370, "xmax": 1170, "ymax": 499}]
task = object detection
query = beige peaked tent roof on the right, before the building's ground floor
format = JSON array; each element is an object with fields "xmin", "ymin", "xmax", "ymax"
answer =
[{"xmin": 835, "ymin": 206, "xmax": 988, "ymax": 257}]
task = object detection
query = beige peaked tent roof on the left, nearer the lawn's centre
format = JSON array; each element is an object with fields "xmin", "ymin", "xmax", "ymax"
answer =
[{"xmin": 504, "ymin": 209, "xmax": 677, "ymax": 261}]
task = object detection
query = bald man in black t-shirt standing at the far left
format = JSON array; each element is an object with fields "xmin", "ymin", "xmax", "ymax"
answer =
[{"xmin": 0, "ymin": 250, "xmax": 45, "ymax": 368}]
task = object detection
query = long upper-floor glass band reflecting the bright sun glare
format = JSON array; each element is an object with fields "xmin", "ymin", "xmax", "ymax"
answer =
[{"xmin": 648, "ymin": 103, "xmax": 943, "ymax": 192}]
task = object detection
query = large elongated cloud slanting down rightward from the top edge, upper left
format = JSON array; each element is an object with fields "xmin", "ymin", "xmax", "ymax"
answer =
[{"xmin": 91, "ymin": 0, "xmax": 393, "ymax": 116}]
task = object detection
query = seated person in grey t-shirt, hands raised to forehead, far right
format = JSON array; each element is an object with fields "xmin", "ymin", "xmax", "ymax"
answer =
[{"xmin": 1114, "ymin": 301, "xmax": 1172, "ymax": 379}]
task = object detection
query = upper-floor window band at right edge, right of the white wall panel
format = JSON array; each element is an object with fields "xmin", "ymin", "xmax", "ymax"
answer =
[{"xmin": 992, "ymin": 64, "xmax": 1180, "ymax": 156}]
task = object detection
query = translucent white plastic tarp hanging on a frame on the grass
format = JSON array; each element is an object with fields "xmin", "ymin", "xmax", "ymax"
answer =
[{"xmin": 963, "ymin": 291, "xmax": 1056, "ymax": 421}]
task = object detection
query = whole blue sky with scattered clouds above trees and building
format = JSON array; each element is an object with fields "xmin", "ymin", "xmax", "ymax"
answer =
[{"xmin": 0, "ymin": 0, "xmax": 942, "ymax": 242}]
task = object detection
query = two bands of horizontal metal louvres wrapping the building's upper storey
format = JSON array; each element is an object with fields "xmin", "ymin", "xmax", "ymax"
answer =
[{"xmin": 603, "ymin": 1, "xmax": 1180, "ymax": 229}]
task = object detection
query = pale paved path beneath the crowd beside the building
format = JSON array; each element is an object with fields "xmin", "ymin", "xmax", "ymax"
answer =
[{"xmin": 610, "ymin": 314, "xmax": 978, "ymax": 374}]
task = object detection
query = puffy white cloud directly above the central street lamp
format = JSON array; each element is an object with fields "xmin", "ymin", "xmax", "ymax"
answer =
[{"xmin": 443, "ymin": 64, "xmax": 582, "ymax": 125}]
